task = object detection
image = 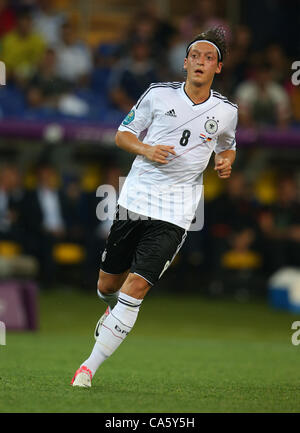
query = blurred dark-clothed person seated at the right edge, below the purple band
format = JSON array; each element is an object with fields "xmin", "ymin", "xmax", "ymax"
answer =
[{"xmin": 259, "ymin": 176, "xmax": 300, "ymax": 272}]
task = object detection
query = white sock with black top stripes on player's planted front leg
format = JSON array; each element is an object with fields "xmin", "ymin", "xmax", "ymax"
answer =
[{"xmin": 81, "ymin": 292, "xmax": 142, "ymax": 376}]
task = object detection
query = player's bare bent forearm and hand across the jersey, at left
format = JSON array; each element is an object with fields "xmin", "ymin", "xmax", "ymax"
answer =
[{"xmin": 116, "ymin": 131, "xmax": 176, "ymax": 164}]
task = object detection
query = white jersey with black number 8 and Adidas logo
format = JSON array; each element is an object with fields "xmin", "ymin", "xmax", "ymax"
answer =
[{"xmin": 118, "ymin": 82, "xmax": 237, "ymax": 230}]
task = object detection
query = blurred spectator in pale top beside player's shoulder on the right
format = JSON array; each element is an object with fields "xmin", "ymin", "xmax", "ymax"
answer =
[{"xmin": 235, "ymin": 64, "xmax": 290, "ymax": 127}]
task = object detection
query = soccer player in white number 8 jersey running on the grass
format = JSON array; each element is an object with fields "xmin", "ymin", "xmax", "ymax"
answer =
[{"xmin": 71, "ymin": 28, "xmax": 237, "ymax": 387}]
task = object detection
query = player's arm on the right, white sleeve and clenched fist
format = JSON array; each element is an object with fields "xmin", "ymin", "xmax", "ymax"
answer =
[{"xmin": 214, "ymin": 111, "xmax": 237, "ymax": 179}]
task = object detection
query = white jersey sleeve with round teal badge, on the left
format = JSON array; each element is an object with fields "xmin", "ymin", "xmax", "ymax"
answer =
[{"xmin": 118, "ymin": 87, "xmax": 153, "ymax": 136}]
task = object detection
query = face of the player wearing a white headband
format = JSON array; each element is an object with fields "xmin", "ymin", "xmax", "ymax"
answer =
[{"xmin": 184, "ymin": 42, "xmax": 222, "ymax": 86}]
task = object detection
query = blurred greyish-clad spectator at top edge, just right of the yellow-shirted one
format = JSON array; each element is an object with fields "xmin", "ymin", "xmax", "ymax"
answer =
[{"xmin": 33, "ymin": 0, "xmax": 65, "ymax": 46}]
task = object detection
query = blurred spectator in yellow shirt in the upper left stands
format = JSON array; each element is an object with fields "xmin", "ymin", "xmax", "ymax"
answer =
[{"xmin": 1, "ymin": 9, "xmax": 45, "ymax": 84}]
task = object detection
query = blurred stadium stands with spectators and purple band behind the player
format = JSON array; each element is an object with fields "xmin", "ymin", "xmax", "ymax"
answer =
[{"xmin": 0, "ymin": 0, "xmax": 300, "ymax": 412}]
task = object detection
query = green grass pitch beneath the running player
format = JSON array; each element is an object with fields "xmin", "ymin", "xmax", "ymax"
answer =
[{"xmin": 0, "ymin": 290, "xmax": 300, "ymax": 413}]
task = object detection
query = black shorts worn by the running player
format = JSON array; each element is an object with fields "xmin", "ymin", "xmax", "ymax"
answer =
[{"xmin": 101, "ymin": 207, "xmax": 187, "ymax": 285}]
